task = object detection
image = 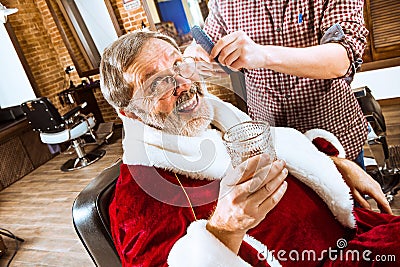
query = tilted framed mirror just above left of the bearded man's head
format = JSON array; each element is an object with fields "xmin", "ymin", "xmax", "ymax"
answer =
[{"xmin": 46, "ymin": 0, "xmax": 122, "ymax": 77}]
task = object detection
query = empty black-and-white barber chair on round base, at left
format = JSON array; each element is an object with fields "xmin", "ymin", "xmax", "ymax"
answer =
[{"xmin": 21, "ymin": 97, "xmax": 106, "ymax": 171}]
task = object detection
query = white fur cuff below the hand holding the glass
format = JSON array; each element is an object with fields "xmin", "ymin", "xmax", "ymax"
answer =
[{"xmin": 168, "ymin": 220, "xmax": 250, "ymax": 267}]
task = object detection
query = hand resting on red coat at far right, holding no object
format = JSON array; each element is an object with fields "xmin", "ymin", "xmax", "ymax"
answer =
[{"xmin": 332, "ymin": 158, "xmax": 393, "ymax": 214}]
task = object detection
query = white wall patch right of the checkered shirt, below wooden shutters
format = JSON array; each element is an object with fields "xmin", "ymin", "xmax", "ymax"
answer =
[{"xmin": 351, "ymin": 66, "xmax": 400, "ymax": 99}]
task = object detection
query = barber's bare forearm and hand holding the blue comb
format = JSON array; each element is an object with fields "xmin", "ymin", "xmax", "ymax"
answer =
[{"xmin": 210, "ymin": 31, "xmax": 350, "ymax": 79}]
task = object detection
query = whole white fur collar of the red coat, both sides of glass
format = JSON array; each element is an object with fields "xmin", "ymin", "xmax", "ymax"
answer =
[{"xmin": 122, "ymin": 95, "xmax": 355, "ymax": 228}]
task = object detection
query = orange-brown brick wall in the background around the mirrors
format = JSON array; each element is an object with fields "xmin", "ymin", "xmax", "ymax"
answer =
[{"xmin": 2, "ymin": 0, "xmax": 238, "ymax": 124}]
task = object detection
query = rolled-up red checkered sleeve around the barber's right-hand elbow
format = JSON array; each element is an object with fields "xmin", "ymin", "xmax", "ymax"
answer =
[{"xmin": 321, "ymin": 0, "xmax": 368, "ymax": 77}]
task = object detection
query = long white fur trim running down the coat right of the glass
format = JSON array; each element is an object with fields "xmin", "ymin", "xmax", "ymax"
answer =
[{"xmin": 271, "ymin": 127, "xmax": 356, "ymax": 228}]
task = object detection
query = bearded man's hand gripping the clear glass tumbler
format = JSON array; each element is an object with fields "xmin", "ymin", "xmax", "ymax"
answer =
[{"xmin": 207, "ymin": 154, "xmax": 288, "ymax": 252}]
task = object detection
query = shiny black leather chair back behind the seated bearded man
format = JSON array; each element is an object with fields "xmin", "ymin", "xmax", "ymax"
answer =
[{"xmin": 72, "ymin": 160, "xmax": 121, "ymax": 267}]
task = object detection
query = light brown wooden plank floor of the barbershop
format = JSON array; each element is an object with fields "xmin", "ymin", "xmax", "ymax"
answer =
[{"xmin": 0, "ymin": 99, "xmax": 400, "ymax": 267}]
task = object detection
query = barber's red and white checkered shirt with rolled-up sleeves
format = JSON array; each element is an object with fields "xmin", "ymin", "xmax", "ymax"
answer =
[{"xmin": 204, "ymin": 0, "xmax": 368, "ymax": 159}]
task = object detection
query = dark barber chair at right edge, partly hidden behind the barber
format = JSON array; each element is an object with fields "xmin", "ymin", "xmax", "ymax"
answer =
[{"xmin": 353, "ymin": 86, "xmax": 400, "ymax": 200}]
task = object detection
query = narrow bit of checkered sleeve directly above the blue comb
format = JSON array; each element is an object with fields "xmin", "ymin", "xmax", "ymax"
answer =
[{"xmin": 203, "ymin": 0, "xmax": 226, "ymax": 42}]
